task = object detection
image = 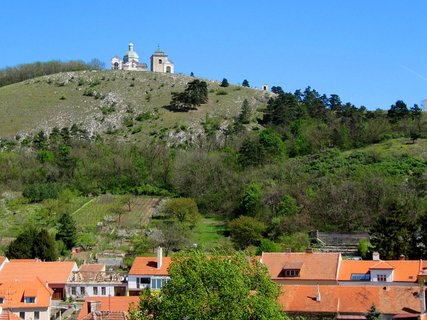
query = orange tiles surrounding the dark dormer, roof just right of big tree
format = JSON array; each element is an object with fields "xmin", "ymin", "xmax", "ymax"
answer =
[{"xmin": 261, "ymin": 252, "xmax": 340, "ymax": 280}]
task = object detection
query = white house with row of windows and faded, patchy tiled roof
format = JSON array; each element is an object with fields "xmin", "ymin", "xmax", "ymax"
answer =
[{"xmin": 67, "ymin": 264, "xmax": 127, "ymax": 298}]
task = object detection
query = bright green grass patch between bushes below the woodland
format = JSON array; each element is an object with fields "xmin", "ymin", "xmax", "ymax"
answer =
[{"xmin": 191, "ymin": 217, "xmax": 227, "ymax": 250}]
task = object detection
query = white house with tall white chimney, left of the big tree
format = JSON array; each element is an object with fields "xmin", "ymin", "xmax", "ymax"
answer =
[{"xmin": 128, "ymin": 247, "xmax": 171, "ymax": 296}]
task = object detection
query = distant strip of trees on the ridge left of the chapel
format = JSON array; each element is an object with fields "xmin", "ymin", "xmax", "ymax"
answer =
[{"xmin": 0, "ymin": 59, "xmax": 104, "ymax": 87}]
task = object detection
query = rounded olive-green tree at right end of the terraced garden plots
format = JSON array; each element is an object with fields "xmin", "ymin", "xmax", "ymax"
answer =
[{"xmin": 161, "ymin": 198, "xmax": 199, "ymax": 225}]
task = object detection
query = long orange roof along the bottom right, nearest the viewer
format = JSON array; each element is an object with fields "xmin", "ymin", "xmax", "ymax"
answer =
[{"xmin": 279, "ymin": 285, "xmax": 420, "ymax": 314}]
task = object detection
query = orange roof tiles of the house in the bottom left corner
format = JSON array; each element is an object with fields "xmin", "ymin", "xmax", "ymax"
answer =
[{"xmin": 0, "ymin": 278, "xmax": 53, "ymax": 308}]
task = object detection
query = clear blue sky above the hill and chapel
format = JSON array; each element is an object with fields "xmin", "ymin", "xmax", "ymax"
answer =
[{"xmin": 0, "ymin": 0, "xmax": 427, "ymax": 109}]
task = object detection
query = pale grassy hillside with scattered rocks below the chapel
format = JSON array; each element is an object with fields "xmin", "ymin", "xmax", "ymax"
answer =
[{"xmin": 0, "ymin": 71, "xmax": 269, "ymax": 141}]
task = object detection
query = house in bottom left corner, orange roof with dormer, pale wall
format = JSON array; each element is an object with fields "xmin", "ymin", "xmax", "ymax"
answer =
[{"xmin": 0, "ymin": 277, "xmax": 53, "ymax": 320}]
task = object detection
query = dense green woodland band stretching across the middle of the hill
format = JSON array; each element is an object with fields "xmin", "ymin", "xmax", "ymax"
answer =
[{"xmin": 0, "ymin": 72, "xmax": 427, "ymax": 258}]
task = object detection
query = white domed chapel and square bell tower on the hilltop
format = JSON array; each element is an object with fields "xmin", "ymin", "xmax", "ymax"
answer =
[{"xmin": 111, "ymin": 42, "xmax": 175, "ymax": 73}]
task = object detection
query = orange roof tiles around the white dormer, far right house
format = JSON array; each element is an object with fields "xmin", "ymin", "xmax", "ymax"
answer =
[{"xmin": 338, "ymin": 260, "xmax": 422, "ymax": 282}]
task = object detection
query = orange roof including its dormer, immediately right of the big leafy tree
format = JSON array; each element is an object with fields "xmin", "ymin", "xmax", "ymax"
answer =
[{"xmin": 260, "ymin": 250, "xmax": 342, "ymax": 285}]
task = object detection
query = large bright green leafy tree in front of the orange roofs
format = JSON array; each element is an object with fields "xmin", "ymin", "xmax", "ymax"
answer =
[{"xmin": 144, "ymin": 250, "xmax": 286, "ymax": 320}]
